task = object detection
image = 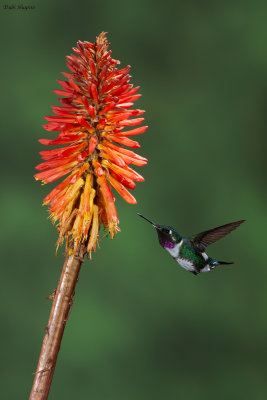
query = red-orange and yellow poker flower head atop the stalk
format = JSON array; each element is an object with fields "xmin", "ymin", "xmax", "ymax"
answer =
[{"xmin": 35, "ymin": 32, "xmax": 147, "ymax": 253}]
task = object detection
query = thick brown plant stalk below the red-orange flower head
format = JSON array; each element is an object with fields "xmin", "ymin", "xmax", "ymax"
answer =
[{"xmin": 30, "ymin": 249, "xmax": 84, "ymax": 400}]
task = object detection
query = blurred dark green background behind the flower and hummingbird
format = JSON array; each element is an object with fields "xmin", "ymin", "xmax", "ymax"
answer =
[{"xmin": 0, "ymin": 0, "xmax": 267, "ymax": 400}]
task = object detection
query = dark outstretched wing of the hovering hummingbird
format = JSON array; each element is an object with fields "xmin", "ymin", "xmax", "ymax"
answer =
[{"xmin": 191, "ymin": 219, "xmax": 245, "ymax": 252}]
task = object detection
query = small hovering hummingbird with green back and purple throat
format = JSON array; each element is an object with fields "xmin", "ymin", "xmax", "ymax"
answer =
[{"xmin": 138, "ymin": 213, "xmax": 245, "ymax": 275}]
